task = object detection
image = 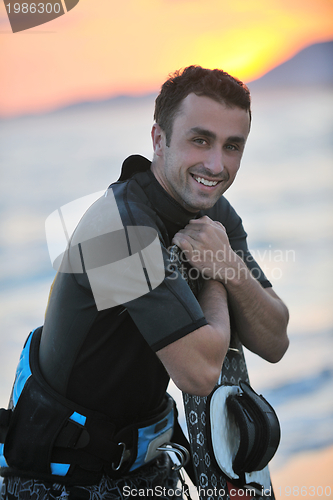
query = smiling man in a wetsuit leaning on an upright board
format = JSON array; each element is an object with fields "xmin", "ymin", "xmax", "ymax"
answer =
[{"xmin": 2, "ymin": 66, "xmax": 288, "ymax": 500}]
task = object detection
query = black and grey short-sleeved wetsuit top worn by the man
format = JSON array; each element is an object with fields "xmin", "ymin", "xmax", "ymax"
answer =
[{"xmin": 40, "ymin": 156, "xmax": 271, "ymax": 427}]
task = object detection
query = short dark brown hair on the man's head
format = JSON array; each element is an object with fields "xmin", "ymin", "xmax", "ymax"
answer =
[{"xmin": 154, "ymin": 66, "xmax": 251, "ymax": 146}]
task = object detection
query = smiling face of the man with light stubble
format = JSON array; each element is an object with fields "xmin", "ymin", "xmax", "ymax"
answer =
[{"xmin": 152, "ymin": 94, "xmax": 250, "ymax": 212}]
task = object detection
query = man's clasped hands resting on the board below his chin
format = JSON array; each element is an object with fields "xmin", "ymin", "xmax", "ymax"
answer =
[{"xmin": 172, "ymin": 215, "xmax": 239, "ymax": 282}]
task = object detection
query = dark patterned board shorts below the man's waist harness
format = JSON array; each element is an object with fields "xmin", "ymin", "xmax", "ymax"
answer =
[{"xmin": 0, "ymin": 455, "xmax": 184, "ymax": 500}]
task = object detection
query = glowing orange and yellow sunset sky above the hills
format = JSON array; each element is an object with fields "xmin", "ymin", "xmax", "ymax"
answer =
[{"xmin": 0, "ymin": 0, "xmax": 333, "ymax": 116}]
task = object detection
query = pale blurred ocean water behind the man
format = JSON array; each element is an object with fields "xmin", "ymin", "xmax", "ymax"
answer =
[{"xmin": 0, "ymin": 88, "xmax": 333, "ymax": 468}]
